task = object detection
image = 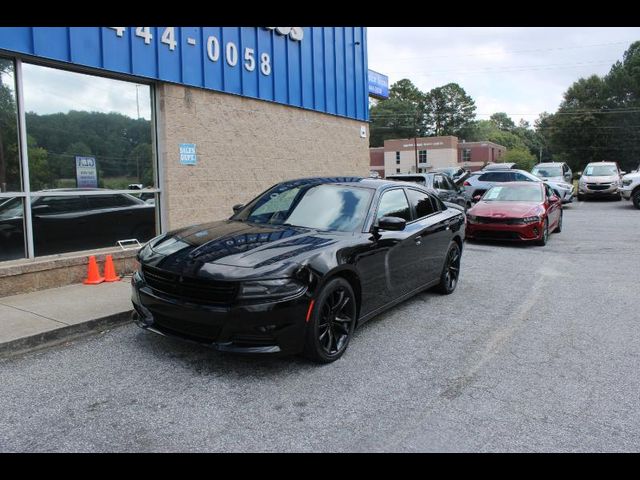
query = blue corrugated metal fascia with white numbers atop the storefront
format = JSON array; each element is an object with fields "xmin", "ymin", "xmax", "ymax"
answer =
[{"xmin": 0, "ymin": 27, "xmax": 369, "ymax": 120}]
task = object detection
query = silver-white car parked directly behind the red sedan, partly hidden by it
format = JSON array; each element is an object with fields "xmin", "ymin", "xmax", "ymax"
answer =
[{"xmin": 463, "ymin": 169, "xmax": 574, "ymax": 203}]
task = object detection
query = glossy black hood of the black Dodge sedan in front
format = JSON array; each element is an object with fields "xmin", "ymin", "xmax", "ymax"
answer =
[{"xmin": 143, "ymin": 220, "xmax": 342, "ymax": 276}]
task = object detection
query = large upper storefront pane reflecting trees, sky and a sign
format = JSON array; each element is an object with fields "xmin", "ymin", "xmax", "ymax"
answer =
[{"xmin": 22, "ymin": 63, "xmax": 155, "ymax": 191}]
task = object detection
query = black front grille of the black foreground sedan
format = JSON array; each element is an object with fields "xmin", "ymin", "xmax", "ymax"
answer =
[{"xmin": 142, "ymin": 266, "xmax": 238, "ymax": 304}]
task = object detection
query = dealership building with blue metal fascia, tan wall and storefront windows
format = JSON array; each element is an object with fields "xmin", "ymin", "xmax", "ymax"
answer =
[{"xmin": 0, "ymin": 27, "xmax": 369, "ymax": 296}]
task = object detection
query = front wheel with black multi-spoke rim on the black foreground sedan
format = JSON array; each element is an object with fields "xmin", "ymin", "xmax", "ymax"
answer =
[{"xmin": 303, "ymin": 277, "xmax": 357, "ymax": 363}]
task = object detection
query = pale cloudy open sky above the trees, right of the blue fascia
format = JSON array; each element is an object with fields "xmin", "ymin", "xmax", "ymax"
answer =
[{"xmin": 367, "ymin": 27, "xmax": 640, "ymax": 125}]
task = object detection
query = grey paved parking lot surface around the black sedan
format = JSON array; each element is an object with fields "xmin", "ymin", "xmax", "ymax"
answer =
[{"xmin": 0, "ymin": 201, "xmax": 640, "ymax": 452}]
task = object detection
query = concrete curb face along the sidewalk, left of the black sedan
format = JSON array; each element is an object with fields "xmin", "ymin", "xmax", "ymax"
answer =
[{"xmin": 0, "ymin": 310, "xmax": 133, "ymax": 359}]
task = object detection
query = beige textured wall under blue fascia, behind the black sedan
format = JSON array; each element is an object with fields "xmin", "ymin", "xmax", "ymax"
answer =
[{"xmin": 157, "ymin": 84, "xmax": 369, "ymax": 229}]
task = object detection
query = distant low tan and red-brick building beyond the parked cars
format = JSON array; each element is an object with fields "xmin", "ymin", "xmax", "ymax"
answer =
[{"xmin": 376, "ymin": 136, "xmax": 507, "ymax": 177}]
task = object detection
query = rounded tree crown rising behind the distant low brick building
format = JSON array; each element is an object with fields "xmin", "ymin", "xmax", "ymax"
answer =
[{"xmin": 425, "ymin": 83, "xmax": 476, "ymax": 136}]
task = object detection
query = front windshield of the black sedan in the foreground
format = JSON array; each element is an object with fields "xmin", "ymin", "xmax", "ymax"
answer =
[{"xmin": 238, "ymin": 184, "xmax": 372, "ymax": 232}]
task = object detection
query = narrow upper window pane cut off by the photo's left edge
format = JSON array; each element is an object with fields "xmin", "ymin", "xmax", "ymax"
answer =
[{"xmin": 0, "ymin": 57, "xmax": 22, "ymax": 194}]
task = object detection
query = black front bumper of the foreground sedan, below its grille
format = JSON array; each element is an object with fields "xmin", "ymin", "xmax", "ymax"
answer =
[{"xmin": 131, "ymin": 273, "xmax": 309, "ymax": 354}]
